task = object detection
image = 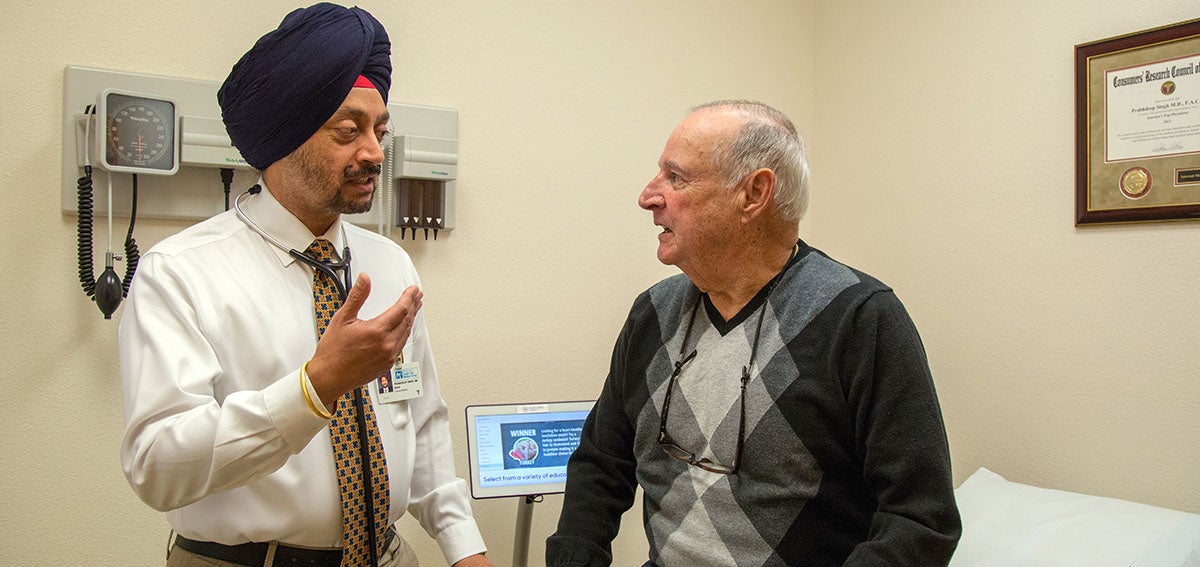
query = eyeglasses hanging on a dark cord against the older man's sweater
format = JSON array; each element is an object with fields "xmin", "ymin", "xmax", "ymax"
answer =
[{"xmin": 659, "ymin": 246, "xmax": 798, "ymax": 475}]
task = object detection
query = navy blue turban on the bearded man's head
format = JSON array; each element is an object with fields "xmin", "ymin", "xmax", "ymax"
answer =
[{"xmin": 217, "ymin": 2, "xmax": 391, "ymax": 169}]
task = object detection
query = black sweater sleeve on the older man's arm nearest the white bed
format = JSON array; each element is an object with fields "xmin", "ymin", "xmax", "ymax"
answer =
[{"xmin": 840, "ymin": 291, "xmax": 962, "ymax": 567}]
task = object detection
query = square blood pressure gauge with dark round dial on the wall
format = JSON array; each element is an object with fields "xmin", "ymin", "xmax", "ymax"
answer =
[{"xmin": 96, "ymin": 89, "xmax": 179, "ymax": 175}]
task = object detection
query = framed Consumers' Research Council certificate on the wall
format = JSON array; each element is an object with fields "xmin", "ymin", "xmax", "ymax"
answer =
[{"xmin": 1075, "ymin": 19, "xmax": 1200, "ymax": 226}]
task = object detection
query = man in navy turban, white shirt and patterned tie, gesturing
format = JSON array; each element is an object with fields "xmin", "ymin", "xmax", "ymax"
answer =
[{"xmin": 120, "ymin": 4, "xmax": 492, "ymax": 567}]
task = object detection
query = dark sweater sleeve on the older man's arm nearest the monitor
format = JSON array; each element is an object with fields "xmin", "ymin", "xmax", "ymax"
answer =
[{"xmin": 546, "ymin": 303, "xmax": 644, "ymax": 567}]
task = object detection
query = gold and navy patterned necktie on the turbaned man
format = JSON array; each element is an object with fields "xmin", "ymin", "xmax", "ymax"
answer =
[{"xmin": 306, "ymin": 238, "xmax": 390, "ymax": 567}]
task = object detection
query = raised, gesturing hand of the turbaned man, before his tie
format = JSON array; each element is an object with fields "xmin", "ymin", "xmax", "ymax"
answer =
[{"xmin": 307, "ymin": 274, "xmax": 424, "ymax": 408}]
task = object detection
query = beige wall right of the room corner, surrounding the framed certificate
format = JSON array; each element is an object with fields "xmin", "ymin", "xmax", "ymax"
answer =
[{"xmin": 809, "ymin": 0, "xmax": 1200, "ymax": 512}]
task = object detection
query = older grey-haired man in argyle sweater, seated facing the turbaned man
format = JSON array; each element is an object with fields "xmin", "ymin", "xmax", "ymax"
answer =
[{"xmin": 546, "ymin": 101, "xmax": 961, "ymax": 567}]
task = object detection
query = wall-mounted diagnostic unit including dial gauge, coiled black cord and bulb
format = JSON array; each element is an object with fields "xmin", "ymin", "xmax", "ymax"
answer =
[{"xmin": 62, "ymin": 66, "xmax": 458, "ymax": 318}]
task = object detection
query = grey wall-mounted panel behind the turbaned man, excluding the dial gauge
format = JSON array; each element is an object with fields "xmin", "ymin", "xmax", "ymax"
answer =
[{"xmin": 61, "ymin": 66, "xmax": 458, "ymax": 238}]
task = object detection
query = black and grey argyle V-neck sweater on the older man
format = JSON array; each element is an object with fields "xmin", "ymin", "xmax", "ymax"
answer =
[{"xmin": 546, "ymin": 241, "xmax": 961, "ymax": 567}]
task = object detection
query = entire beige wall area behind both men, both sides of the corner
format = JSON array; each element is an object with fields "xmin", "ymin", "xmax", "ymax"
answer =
[{"xmin": 0, "ymin": 0, "xmax": 1200, "ymax": 566}]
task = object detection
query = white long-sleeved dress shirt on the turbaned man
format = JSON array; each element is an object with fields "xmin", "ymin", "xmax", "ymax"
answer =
[{"xmin": 120, "ymin": 184, "xmax": 485, "ymax": 563}]
